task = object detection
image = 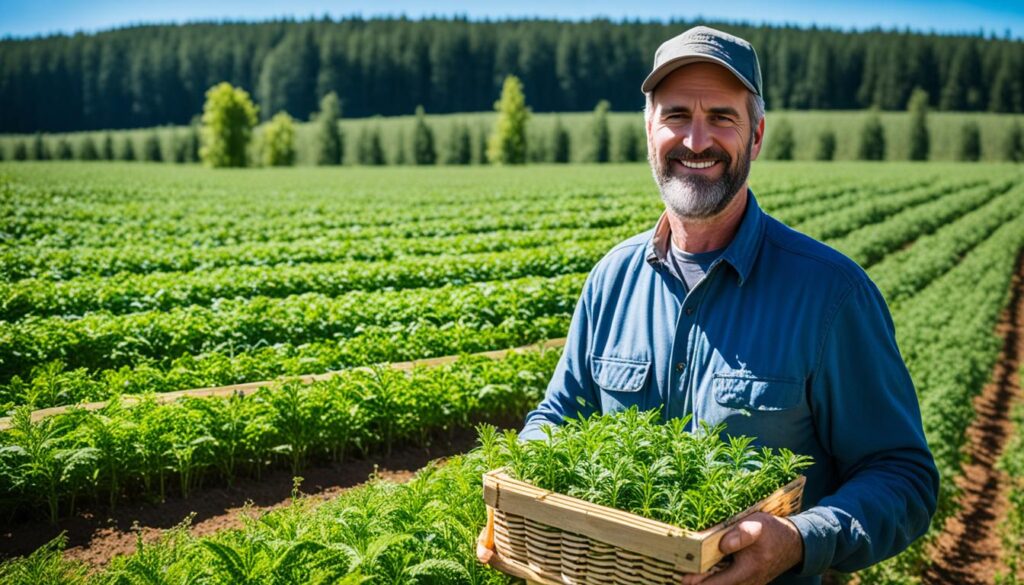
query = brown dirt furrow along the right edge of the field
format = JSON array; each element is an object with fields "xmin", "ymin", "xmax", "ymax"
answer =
[{"xmin": 922, "ymin": 254, "xmax": 1024, "ymax": 585}]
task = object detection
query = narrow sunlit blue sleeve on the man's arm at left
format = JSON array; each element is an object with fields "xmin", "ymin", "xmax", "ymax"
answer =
[{"xmin": 519, "ymin": 275, "xmax": 599, "ymax": 441}]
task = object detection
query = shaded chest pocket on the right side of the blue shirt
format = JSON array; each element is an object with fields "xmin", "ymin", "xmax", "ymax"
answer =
[{"xmin": 705, "ymin": 372, "xmax": 811, "ymax": 448}]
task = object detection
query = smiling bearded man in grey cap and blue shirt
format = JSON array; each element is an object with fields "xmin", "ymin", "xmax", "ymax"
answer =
[{"xmin": 481, "ymin": 27, "xmax": 938, "ymax": 585}]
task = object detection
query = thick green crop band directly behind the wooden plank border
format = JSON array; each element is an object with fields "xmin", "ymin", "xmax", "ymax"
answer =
[{"xmin": 0, "ymin": 274, "xmax": 585, "ymax": 406}]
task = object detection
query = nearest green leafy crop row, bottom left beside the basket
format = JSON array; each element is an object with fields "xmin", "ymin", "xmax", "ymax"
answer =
[{"xmin": 0, "ymin": 452, "xmax": 513, "ymax": 585}]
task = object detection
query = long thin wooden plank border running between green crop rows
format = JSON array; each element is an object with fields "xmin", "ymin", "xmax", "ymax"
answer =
[{"xmin": 0, "ymin": 337, "xmax": 565, "ymax": 432}]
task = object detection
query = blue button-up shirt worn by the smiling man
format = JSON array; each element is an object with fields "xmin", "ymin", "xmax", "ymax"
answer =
[{"xmin": 520, "ymin": 193, "xmax": 939, "ymax": 583}]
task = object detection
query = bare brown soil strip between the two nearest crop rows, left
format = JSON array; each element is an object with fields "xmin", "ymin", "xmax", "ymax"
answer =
[{"xmin": 0, "ymin": 429, "xmax": 476, "ymax": 569}]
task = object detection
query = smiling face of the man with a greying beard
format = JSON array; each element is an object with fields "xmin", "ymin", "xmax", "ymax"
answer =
[{"xmin": 647, "ymin": 62, "xmax": 764, "ymax": 219}]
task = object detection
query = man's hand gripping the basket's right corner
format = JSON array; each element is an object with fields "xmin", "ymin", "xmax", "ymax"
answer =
[{"xmin": 682, "ymin": 512, "xmax": 804, "ymax": 585}]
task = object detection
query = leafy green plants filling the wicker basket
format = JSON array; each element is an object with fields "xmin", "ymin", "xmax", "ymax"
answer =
[{"xmin": 489, "ymin": 407, "xmax": 812, "ymax": 532}]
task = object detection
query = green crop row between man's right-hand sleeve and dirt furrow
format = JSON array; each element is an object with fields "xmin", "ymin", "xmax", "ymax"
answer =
[{"xmin": 859, "ymin": 216, "xmax": 1024, "ymax": 584}]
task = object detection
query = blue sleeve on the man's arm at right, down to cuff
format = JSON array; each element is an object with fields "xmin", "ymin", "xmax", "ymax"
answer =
[{"xmin": 791, "ymin": 279, "xmax": 939, "ymax": 575}]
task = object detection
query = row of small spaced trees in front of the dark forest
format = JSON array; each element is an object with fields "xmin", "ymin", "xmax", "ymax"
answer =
[{"xmin": 6, "ymin": 83, "xmax": 1024, "ymax": 166}]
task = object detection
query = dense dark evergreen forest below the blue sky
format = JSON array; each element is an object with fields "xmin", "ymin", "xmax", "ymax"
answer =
[{"xmin": 0, "ymin": 17, "xmax": 1024, "ymax": 132}]
